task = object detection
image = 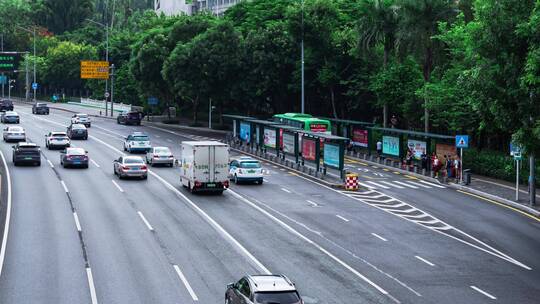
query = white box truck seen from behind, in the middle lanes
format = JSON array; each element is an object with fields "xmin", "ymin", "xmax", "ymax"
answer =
[{"xmin": 180, "ymin": 141, "xmax": 229, "ymax": 193}]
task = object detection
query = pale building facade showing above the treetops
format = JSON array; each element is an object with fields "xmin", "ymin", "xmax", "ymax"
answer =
[{"xmin": 154, "ymin": 0, "xmax": 241, "ymax": 16}]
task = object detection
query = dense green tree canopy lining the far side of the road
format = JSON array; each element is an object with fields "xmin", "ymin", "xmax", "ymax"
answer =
[{"xmin": 0, "ymin": 0, "xmax": 540, "ymax": 157}]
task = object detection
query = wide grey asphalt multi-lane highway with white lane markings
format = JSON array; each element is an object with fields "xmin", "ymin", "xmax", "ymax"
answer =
[{"xmin": 0, "ymin": 104, "xmax": 540, "ymax": 304}]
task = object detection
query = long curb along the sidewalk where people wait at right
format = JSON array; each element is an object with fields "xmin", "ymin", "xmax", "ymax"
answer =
[{"xmin": 347, "ymin": 156, "xmax": 540, "ymax": 218}]
